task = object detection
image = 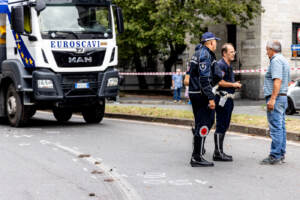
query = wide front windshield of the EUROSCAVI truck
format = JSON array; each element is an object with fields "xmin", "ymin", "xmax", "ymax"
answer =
[{"xmin": 39, "ymin": 4, "xmax": 112, "ymax": 39}]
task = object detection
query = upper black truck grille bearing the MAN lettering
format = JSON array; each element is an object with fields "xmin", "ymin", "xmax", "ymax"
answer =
[{"xmin": 52, "ymin": 50, "xmax": 106, "ymax": 67}]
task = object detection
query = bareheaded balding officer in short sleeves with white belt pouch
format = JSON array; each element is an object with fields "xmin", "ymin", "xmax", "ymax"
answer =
[{"xmin": 213, "ymin": 43, "xmax": 242, "ymax": 161}]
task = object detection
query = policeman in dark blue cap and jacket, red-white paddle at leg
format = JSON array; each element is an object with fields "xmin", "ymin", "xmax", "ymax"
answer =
[{"xmin": 189, "ymin": 32, "xmax": 222, "ymax": 167}]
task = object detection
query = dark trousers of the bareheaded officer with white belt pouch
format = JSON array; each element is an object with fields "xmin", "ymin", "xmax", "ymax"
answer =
[{"xmin": 215, "ymin": 95, "xmax": 234, "ymax": 134}]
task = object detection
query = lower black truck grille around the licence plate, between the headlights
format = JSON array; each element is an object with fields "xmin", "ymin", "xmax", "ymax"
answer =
[{"xmin": 61, "ymin": 73, "xmax": 102, "ymax": 97}]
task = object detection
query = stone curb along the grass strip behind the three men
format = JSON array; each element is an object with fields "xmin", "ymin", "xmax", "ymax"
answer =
[{"xmin": 104, "ymin": 113, "xmax": 300, "ymax": 141}]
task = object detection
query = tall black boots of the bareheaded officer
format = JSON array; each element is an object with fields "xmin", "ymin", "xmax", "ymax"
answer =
[{"xmin": 213, "ymin": 133, "xmax": 233, "ymax": 161}]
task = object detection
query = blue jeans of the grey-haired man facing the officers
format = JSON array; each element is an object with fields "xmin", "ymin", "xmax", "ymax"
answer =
[{"xmin": 266, "ymin": 96, "xmax": 287, "ymax": 159}]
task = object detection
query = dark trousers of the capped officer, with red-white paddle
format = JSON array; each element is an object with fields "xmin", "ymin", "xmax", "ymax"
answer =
[{"xmin": 189, "ymin": 94, "xmax": 215, "ymax": 137}]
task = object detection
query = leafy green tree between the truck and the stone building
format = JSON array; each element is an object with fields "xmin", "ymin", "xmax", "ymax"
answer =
[{"xmin": 115, "ymin": 0, "xmax": 263, "ymax": 88}]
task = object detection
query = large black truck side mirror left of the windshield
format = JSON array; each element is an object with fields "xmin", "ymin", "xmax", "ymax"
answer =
[{"xmin": 11, "ymin": 6, "xmax": 24, "ymax": 34}]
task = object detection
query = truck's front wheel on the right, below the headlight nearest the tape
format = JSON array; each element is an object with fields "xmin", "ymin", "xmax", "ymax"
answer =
[{"xmin": 82, "ymin": 103, "xmax": 105, "ymax": 124}]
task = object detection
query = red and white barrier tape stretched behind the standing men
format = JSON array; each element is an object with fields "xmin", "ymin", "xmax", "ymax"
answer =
[{"xmin": 119, "ymin": 67, "xmax": 300, "ymax": 76}]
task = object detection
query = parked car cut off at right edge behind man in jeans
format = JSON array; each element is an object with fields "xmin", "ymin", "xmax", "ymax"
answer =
[{"xmin": 286, "ymin": 79, "xmax": 300, "ymax": 115}]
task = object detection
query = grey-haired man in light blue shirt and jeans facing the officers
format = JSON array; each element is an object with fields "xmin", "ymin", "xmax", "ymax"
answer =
[{"xmin": 261, "ymin": 41, "xmax": 290, "ymax": 164}]
